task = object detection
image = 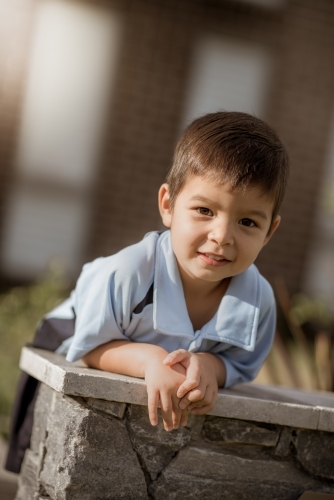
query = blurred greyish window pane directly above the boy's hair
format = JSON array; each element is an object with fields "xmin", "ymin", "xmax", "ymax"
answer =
[{"xmin": 183, "ymin": 36, "xmax": 272, "ymax": 126}]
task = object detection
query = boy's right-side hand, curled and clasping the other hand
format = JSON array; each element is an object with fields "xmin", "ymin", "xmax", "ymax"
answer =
[{"xmin": 164, "ymin": 349, "xmax": 225, "ymax": 415}]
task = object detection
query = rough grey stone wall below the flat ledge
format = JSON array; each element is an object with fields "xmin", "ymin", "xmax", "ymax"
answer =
[{"xmin": 16, "ymin": 384, "xmax": 334, "ymax": 500}]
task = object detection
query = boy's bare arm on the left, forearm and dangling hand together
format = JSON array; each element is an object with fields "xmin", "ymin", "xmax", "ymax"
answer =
[{"xmin": 83, "ymin": 340, "xmax": 188, "ymax": 430}]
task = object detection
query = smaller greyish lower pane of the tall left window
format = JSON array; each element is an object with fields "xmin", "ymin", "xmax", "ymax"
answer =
[{"xmin": 2, "ymin": 186, "xmax": 87, "ymax": 279}]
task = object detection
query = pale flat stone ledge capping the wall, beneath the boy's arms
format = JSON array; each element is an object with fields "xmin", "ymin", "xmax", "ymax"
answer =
[{"xmin": 20, "ymin": 347, "xmax": 334, "ymax": 432}]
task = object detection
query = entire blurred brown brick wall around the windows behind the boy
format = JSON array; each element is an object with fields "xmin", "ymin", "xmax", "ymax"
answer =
[{"xmin": 0, "ymin": 0, "xmax": 334, "ymax": 291}]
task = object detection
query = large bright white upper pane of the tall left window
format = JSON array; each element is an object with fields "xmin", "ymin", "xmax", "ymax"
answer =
[{"xmin": 17, "ymin": 0, "xmax": 120, "ymax": 187}]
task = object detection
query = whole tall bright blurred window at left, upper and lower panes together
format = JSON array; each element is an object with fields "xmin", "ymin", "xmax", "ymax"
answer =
[{"xmin": 1, "ymin": 0, "xmax": 121, "ymax": 279}]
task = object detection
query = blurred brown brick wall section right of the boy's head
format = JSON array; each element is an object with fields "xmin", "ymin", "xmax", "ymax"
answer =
[{"xmin": 259, "ymin": 0, "xmax": 334, "ymax": 291}]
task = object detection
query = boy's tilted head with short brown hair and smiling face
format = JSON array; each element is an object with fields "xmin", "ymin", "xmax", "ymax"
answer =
[{"xmin": 159, "ymin": 112, "xmax": 288, "ymax": 288}]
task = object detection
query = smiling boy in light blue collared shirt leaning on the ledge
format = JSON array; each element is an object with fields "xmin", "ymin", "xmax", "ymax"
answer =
[{"xmin": 48, "ymin": 112, "xmax": 288, "ymax": 431}]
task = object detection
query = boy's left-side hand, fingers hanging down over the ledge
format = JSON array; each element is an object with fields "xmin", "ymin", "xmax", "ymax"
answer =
[{"xmin": 145, "ymin": 357, "xmax": 188, "ymax": 431}]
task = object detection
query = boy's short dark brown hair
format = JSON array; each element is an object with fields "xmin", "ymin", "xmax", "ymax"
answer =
[{"xmin": 166, "ymin": 111, "xmax": 289, "ymax": 219}]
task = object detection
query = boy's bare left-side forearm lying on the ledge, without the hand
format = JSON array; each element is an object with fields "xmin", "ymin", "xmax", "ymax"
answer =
[{"xmin": 83, "ymin": 340, "xmax": 168, "ymax": 378}]
